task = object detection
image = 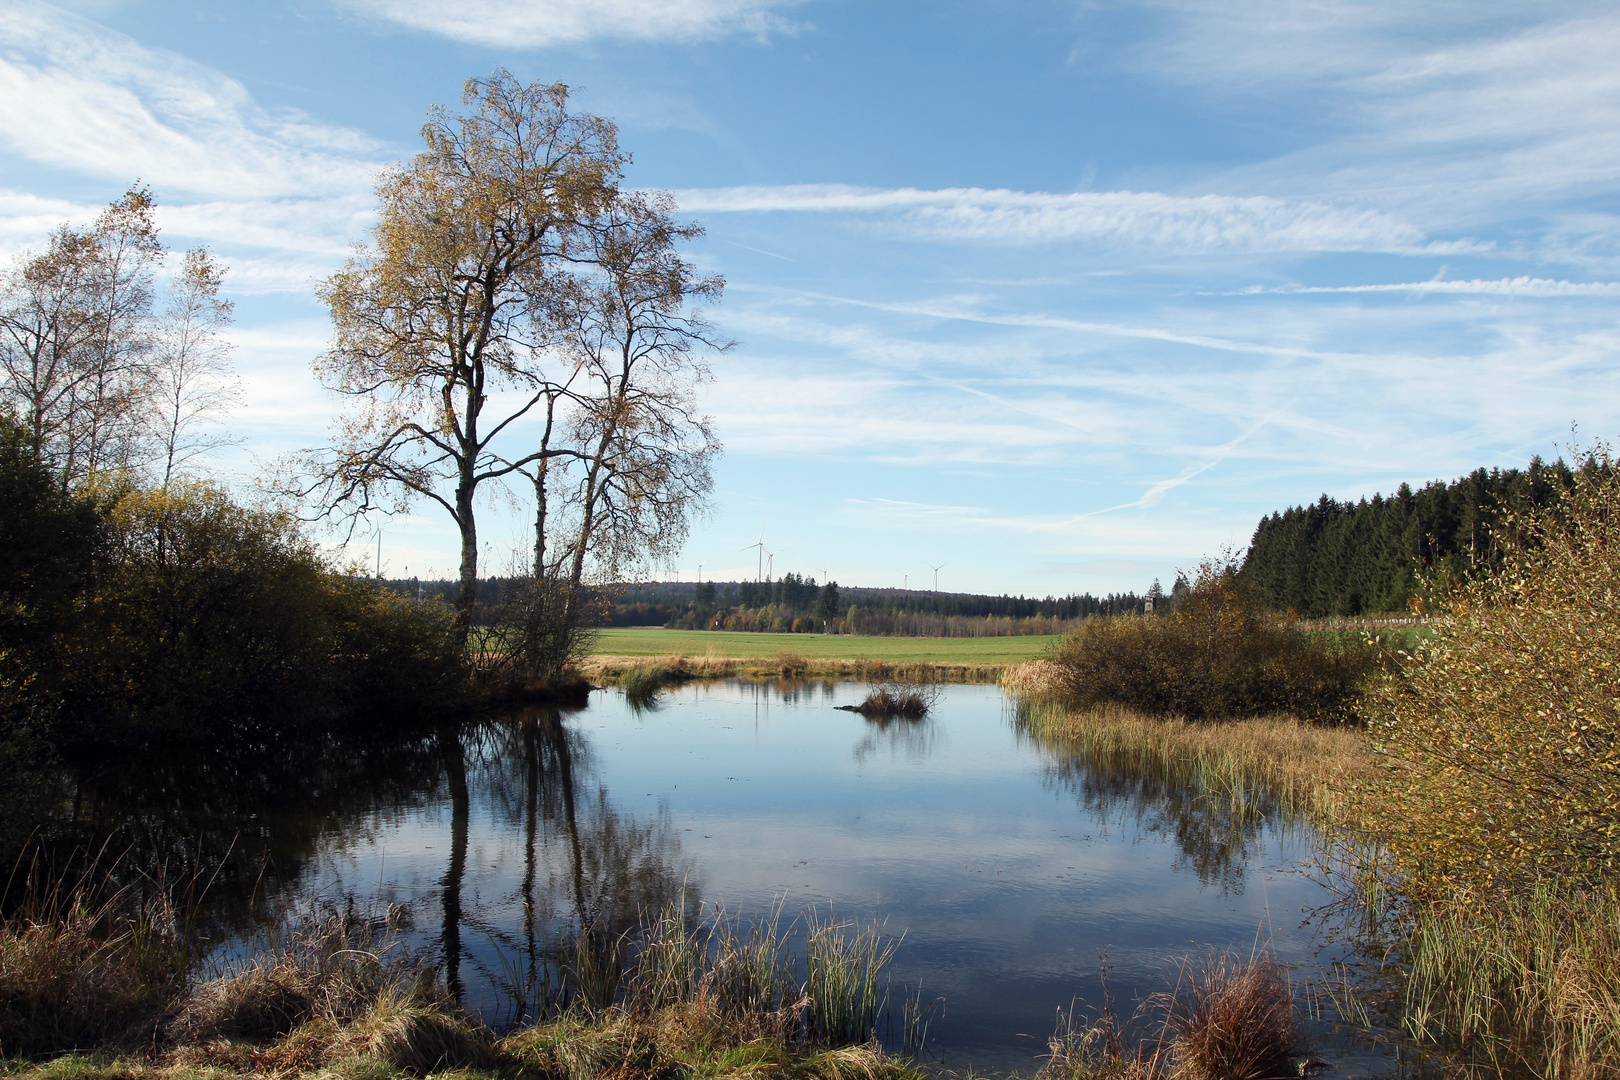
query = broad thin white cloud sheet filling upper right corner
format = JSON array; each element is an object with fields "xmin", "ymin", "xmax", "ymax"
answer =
[{"xmin": 1137, "ymin": 0, "xmax": 1620, "ymax": 243}]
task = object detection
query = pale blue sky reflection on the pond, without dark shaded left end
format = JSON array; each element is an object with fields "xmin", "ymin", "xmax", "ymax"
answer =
[{"xmin": 298, "ymin": 683, "xmax": 1330, "ymax": 1070}]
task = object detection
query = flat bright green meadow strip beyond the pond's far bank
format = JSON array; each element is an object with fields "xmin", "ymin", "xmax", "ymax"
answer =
[{"xmin": 591, "ymin": 627, "xmax": 1059, "ymax": 664}]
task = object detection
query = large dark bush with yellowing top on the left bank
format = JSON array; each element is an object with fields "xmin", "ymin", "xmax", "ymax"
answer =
[{"xmin": 15, "ymin": 483, "xmax": 465, "ymax": 745}]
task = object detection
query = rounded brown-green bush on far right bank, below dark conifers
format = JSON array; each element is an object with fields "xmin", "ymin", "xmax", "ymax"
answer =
[{"xmin": 1053, "ymin": 563, "xmax": 1377, "ymax": 722}]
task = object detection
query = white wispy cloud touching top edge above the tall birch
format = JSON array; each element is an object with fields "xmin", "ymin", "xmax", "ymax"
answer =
[{"xmin": 339, "ymin": 0, "xmax": 802, "ymax": 49}]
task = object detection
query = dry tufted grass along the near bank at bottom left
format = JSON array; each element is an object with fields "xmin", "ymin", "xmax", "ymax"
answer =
[{"xmin": 0, "ymin": 892, "xmax": 922, "ymax": 1080}]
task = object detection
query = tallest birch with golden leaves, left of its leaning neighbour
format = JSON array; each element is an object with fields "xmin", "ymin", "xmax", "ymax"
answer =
[{"xmin": 306, "ymin": 71, "xmax": 625, "ymax": 640}]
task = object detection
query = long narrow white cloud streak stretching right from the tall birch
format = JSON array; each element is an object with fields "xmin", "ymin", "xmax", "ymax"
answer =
[{"xmin": 676, "ymin": 185, "xmax": 1479, "ymax": 253}]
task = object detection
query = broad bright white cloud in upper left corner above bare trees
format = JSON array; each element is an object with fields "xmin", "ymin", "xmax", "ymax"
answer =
[{"xmin": 0, "ymin": 0, "xmax": 387, "ymax": 295}]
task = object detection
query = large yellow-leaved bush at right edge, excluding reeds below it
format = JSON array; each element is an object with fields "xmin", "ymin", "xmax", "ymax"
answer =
[{"xmin": 1359, "ymin": 449, "xmax": 1620, "ymax": 900}]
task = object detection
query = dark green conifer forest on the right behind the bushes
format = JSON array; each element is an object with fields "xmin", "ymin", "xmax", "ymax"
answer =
[{"xmin": 1239, "ymin": 458, "xmax": 1573, "ymax": 617}]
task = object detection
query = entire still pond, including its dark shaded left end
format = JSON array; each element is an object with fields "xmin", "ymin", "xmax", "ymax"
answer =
[{"xmin": 38, "ymin": 682, "xmax": 1358, "ymax": 1072}]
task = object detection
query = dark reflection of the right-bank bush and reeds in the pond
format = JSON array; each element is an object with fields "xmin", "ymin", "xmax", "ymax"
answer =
[{"xmin": 1032, "ymin": 735, "xmax": 1296, "ymax": 892}]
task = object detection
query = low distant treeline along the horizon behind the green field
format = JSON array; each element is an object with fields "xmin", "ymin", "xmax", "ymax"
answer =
[{"xmin": 387, "ymin": 573, "xmax": 1145, "ymax": 638}]
